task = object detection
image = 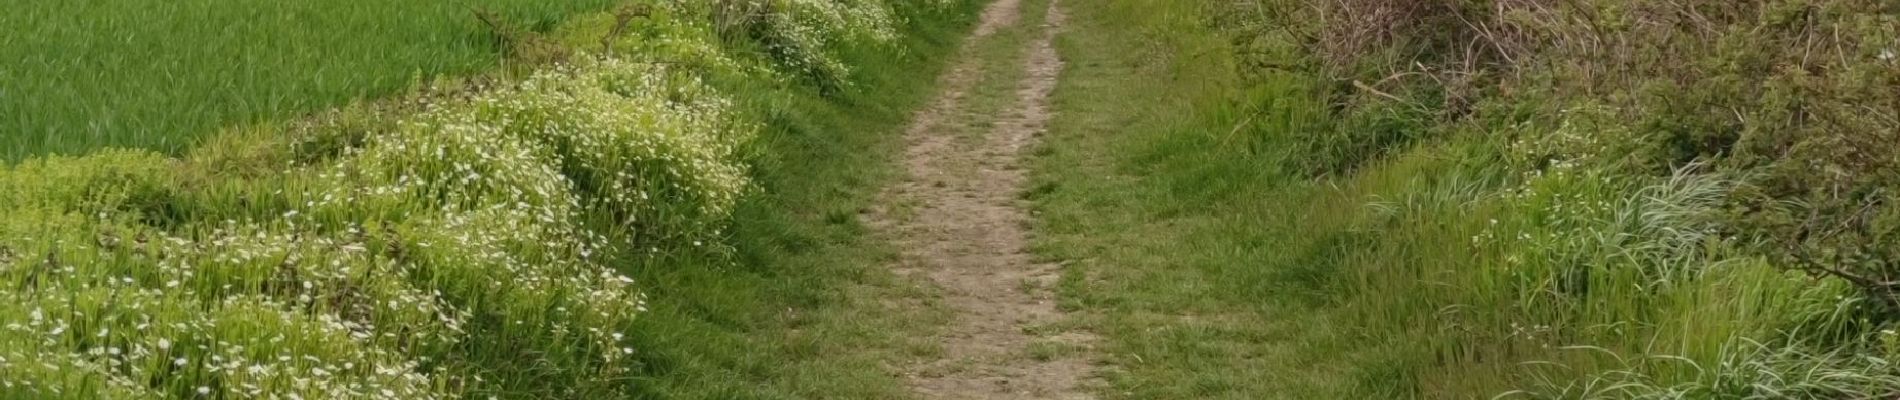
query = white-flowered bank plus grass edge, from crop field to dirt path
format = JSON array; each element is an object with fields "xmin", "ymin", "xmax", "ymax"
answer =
[{"xmin": 0, "ymin": 0, "xmax": 973, "ymax": 398}]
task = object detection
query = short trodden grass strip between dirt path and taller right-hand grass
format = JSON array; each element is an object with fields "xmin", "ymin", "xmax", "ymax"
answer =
[{"xmin": 1032, "ymin": 0, "xmax": 1351, "ymax": 398}]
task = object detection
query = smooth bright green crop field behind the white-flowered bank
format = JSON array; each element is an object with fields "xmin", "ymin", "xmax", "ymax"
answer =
[{"xmin": 0, "ymin": 0, "xmax": 616, "ymax": 161}]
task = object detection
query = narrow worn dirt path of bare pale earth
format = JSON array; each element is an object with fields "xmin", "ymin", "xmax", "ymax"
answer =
[{"xmin": 872, "ymin": 0, "xmax": 1094, "ymax": 398}]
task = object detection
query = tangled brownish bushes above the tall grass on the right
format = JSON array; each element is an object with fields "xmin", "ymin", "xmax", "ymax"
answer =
[{"xmin": 1241, "ymin": 0, "xmax": 1900, "ymax": 309}]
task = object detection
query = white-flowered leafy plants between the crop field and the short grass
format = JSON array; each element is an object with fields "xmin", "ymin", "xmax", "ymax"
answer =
[{"xmin": 0, "ymin": 0, "xmax": 950, "ymax": 398}]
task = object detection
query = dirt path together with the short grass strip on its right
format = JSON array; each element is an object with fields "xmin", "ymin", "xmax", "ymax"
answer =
[{"xmin": 870, "ymin": 0, "xmax": 1360, "ymax": 398}]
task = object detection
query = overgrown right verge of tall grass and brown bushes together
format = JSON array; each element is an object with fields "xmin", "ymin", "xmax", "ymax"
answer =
[{"xmin": 1214, "ymin": 0, "xmax": 1900, "ymax": 398}]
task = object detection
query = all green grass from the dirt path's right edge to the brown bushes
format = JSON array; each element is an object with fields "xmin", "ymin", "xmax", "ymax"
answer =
[{"xmin": 1034, "ymin": 0, "xmax": 1900, "ymax": 398}]
